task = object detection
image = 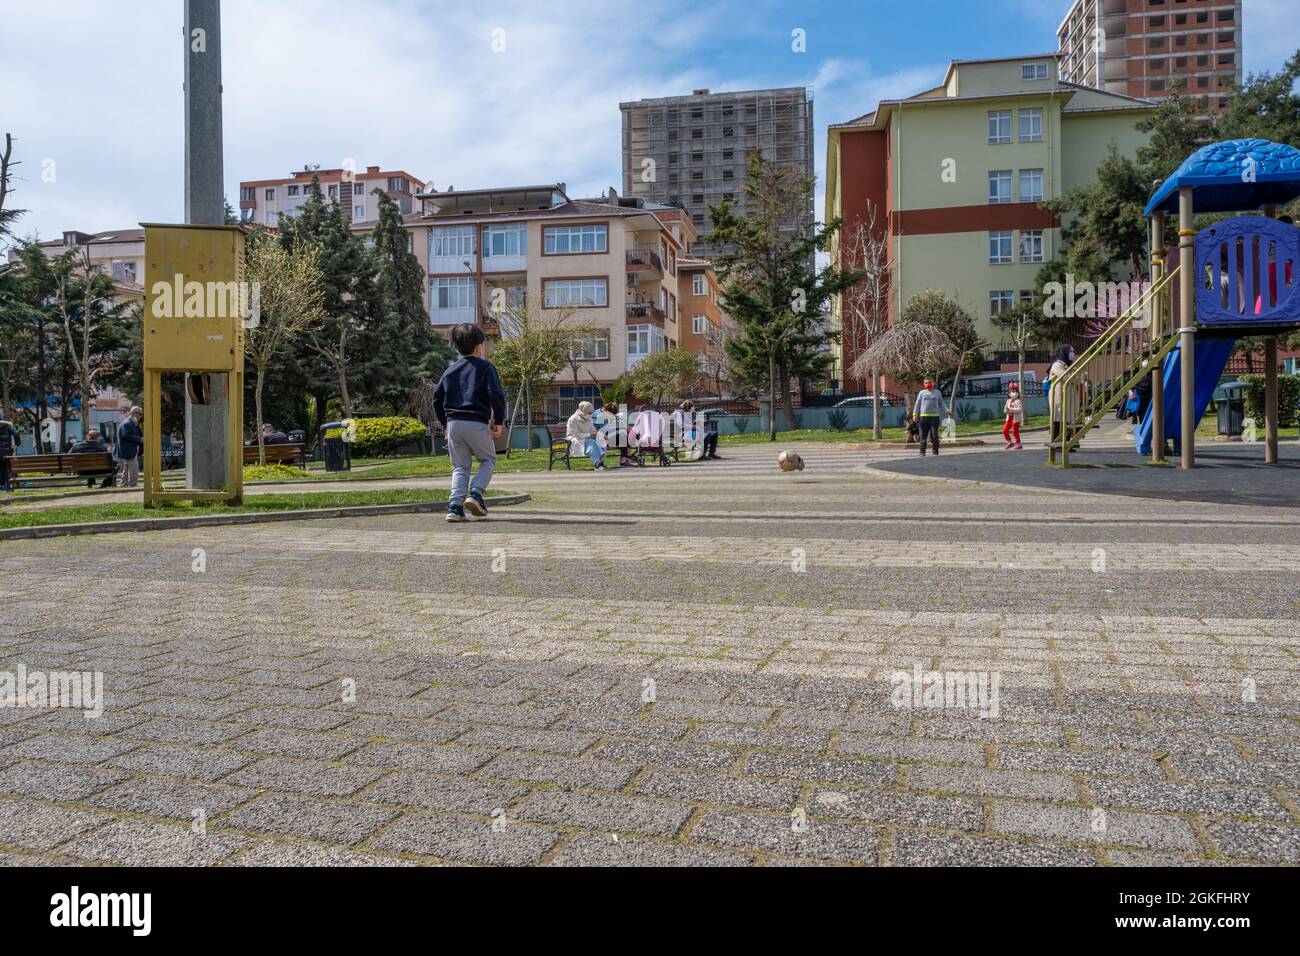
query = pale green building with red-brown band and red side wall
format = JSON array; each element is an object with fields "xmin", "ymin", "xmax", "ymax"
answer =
[{"xmin": 826, "ymin": 53, "xmax": 1154, "ymax": 387}]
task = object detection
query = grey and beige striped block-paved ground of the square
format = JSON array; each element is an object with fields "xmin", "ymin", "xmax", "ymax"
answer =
[{"xmin": 0, "ymin": 446, "xmax": 1300, "ymax": 866}]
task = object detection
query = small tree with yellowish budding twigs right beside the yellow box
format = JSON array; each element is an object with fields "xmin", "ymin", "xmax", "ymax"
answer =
[{"xmin": 244, "ymin": 238, "xmax": 325, "ymax": 464}]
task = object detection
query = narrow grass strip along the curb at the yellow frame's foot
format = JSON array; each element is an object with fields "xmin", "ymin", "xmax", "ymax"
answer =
[{"xmin": 0, "ymin": 488, "xmax": 510, "ymax": 528}]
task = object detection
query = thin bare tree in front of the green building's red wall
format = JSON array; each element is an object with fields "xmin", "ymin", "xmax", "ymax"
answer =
[{"xmin": 839, "ymin": 200, "xmax": 894, "ymax": 441}]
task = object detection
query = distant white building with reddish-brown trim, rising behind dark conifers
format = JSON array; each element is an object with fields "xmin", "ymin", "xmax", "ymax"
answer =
[{"xmin": 239, "ymin": 166, "xmax": 425, "ymax": 228}]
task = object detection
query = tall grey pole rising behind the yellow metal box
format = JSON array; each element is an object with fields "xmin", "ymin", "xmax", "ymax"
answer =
[{"xmin": 185, "ymin": 0, "xmax": 229, "ymax": 489}]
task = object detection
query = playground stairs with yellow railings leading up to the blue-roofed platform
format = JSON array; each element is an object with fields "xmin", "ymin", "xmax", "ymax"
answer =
[{"xmin": 1048, "ymin": 269, "xmax": 1179, "ymax": 467}]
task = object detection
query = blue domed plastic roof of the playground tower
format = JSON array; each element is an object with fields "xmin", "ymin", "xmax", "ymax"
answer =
[{"xmin": 1147, "ymin": 139, "xmax": 1300, "ymax": 216}]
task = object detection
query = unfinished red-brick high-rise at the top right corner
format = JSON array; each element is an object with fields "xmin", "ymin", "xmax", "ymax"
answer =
[{"xmin": 1057, "ymin": 0, "xmax": 1242, "ymax": 118}]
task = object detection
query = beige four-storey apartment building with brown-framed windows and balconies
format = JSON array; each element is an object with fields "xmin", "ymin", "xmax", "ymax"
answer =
[{"xmin": 387, "ymin": 183, "xmax": 712, "ymax": 414}]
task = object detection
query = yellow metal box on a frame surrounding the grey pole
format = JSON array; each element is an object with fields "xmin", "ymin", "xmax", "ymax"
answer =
[{"xmin": 142, "ymin": 222, "xmax": 244, "ymax": 507}]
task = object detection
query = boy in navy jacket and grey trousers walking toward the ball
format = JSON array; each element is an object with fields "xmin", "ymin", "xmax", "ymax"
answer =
[{"xmin": 433, "ymin": 323, "xmax": 506, "ymax": 522}]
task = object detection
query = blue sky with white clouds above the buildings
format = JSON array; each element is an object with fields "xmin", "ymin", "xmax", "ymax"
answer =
[{"xmin": 0, "ymin": 0, "xmax": 1300, "ymax": 247}]
